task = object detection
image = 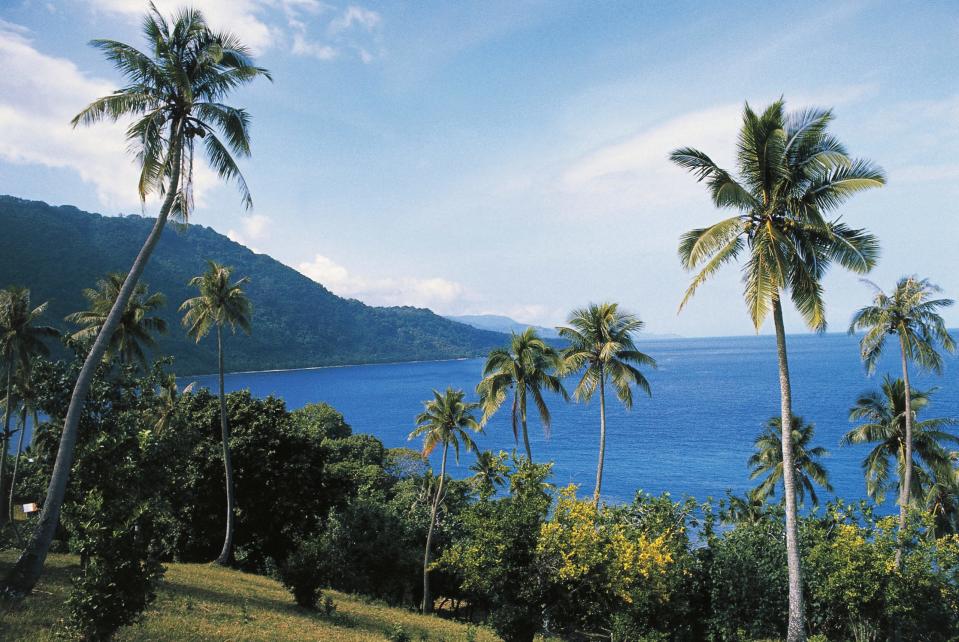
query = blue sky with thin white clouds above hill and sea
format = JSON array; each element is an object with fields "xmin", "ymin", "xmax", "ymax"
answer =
[{"xmin": 0, "ymin": 0, "xmax": 959, "ymax": 336}]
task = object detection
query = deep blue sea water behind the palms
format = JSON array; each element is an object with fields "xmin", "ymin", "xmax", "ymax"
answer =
[{"xmin": 183, "ymin": 334, "xmax": 959, "ymax": 508}]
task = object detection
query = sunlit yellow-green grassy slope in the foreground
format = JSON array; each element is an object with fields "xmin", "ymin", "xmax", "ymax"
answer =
[{"xmin": 0, "ymin": 551, "xmax": 498, "ymax": 642}]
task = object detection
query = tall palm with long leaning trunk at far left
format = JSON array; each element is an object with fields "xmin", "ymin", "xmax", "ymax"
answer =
[{"xmin": 4, "ymin": 6, "xmax": 270, "ymax": 595}]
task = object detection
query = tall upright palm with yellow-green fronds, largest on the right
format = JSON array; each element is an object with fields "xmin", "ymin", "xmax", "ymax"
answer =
[{"xmin": 670, "ymin": 100, "xmax": 885, "ymax": 642}]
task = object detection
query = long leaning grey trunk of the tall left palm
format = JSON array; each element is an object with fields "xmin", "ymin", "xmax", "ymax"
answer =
[{"xmin": 3, "ymin": 122, "xmax": 182, "ymax": 595}]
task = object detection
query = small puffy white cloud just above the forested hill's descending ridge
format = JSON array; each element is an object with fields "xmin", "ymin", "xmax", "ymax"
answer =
[{"xmin": 297, "ymin": 254, "xmax": 469, "ymax": 314}]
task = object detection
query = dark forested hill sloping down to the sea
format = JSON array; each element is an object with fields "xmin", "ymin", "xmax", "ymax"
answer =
[{"xmin": 0, "ymin": 196, "xmax": 505, "ymax": 374}]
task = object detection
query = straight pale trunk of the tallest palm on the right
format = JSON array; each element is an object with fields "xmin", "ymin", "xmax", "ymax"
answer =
[{"xmin": 773, "ymin": 297, "xmax": 806, "ymax": 642}]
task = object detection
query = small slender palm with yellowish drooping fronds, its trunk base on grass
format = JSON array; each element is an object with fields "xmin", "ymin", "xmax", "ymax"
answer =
[{"xmin": 409, "ymin": 388, "xmax": 482, "ymax": 613}]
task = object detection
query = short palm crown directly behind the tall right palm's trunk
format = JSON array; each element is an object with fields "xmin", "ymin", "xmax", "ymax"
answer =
[{"xmin": 748, "ymin": 415, "xmax": 832, "ymax": 506}]
